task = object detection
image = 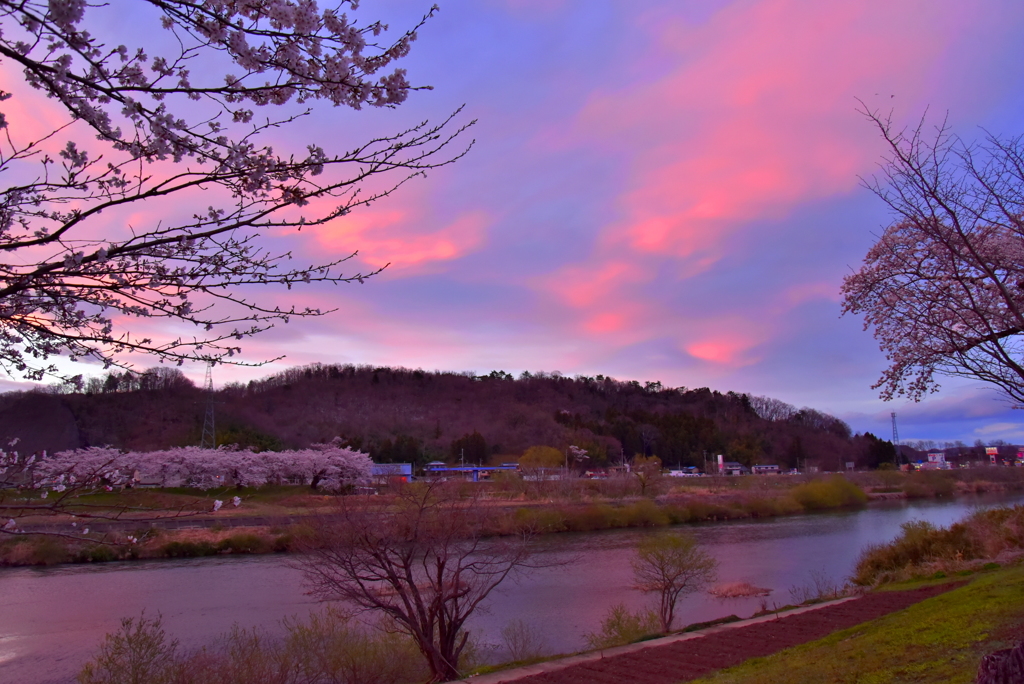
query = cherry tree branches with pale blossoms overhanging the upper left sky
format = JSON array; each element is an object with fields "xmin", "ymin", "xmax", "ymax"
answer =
[{"xmin": 0, "ymin": 0, "xmax": 471, "ymax": 379}]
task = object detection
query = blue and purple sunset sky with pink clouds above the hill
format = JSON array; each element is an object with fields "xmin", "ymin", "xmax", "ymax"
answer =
[{"xmin": 9, "ymin": 0, "xmax": 1024, "ymax": 443}]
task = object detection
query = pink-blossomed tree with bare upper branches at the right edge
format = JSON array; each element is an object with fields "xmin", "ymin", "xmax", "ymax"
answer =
[{"xmin": 843, "ymin": 111, "xmax": 1024, "ymax": 403}]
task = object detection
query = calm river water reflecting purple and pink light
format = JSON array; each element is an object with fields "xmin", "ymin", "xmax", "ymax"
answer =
[{"xmin": 0, "ymin": 495, "xmax": 1024, "ymax": 684}]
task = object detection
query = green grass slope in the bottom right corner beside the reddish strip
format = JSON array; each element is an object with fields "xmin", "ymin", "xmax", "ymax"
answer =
[{"xmin": 679, "ymin": 565, "xmax": 1024, "ymax": 684}]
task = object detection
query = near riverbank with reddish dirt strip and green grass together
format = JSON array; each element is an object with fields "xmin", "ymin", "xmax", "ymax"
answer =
[{"xmin": 464, "ymin": 564, "xmax": 1024, "ymax": 684}]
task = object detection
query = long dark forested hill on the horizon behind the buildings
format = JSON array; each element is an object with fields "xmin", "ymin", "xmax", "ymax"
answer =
[{"xmin": 0, "ymin": 365, "xmax": 893, "ymax": 470}]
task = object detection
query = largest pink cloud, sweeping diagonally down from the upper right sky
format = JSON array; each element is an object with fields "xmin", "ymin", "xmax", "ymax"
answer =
[{"xmin": 575, "ymin": 0, "xmax": 964, "ymax": 257}]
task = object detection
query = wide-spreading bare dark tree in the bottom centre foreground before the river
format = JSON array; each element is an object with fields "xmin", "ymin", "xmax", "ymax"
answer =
[{"xmin": 299, "ymin": 482, "xmax": 529, "ymax": 682}]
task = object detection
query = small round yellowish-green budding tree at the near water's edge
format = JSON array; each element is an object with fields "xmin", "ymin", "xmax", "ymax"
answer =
[{"xmin": 630, "ymin": 532, "xmax": 718, "ymax": 632}]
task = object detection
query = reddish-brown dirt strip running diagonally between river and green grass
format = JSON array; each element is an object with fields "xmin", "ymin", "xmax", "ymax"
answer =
[{"xmin": 468, "ymin": 583, "xmax": 962, "ymax": 684}]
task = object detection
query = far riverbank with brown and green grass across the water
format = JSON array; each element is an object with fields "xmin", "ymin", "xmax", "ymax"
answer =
[{"xmin": 8, "ymin": 468, "xmax": 1024, "ymax": 566}]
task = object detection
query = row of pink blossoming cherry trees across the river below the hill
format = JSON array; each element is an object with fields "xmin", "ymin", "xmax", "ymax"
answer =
[{"xmin": 29, "ymin": 443, "xmax": 372, "ymax": 491}]
